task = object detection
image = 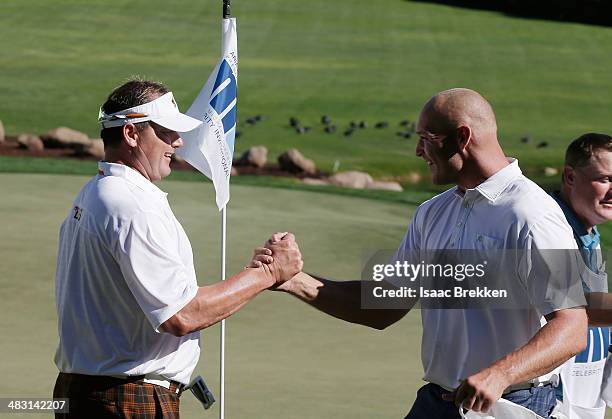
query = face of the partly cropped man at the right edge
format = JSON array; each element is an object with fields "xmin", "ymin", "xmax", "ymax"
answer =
[{"xmin": 564, "ymin": 150, "xmax": 612, "ymax": 228}]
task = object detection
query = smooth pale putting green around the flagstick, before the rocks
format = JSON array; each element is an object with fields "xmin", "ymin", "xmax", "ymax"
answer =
[{"xmin": 0, "ymin": 174, "xmax": 421, "ymax": 419}]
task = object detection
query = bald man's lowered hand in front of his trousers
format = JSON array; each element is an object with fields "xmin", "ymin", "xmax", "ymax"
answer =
[{"xmin": 442, "ymin": 367, "xmax": 510, "ymax": 412}]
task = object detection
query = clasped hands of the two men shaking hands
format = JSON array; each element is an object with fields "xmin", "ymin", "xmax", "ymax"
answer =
[{"xmin": 245, "ymin": 232, "xmax": 304, "ymax": 288}]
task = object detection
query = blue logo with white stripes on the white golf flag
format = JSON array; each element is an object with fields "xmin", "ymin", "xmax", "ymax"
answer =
[{"xmin": 210, "ymin": 60, "xmax": 237, "ymax": 154}]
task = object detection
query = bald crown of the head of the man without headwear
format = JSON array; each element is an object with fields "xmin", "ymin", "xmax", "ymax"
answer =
[{"xmin": 421, "ymin": 88, "xmax": 497, "ymax": 138}]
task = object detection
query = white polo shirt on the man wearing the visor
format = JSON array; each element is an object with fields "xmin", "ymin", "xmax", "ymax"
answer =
[{"xmin": 55, "ymin": 162, "xmax": 200, "ymax": 384}]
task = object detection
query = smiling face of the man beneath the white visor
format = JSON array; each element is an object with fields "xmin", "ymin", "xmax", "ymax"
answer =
[{"xmin": 132, "ymin": 122, "xmax": 183, "ymax": 182}]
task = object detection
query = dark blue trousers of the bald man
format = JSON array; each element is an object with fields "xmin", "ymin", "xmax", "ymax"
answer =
[{"xmin": 405, "ymin": 383, "xmax": 556, "ymax": 419}]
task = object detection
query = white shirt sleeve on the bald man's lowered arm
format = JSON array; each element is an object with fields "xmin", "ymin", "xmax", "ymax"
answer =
[{"xmin": 521, "ymin": 214, "xmax": 586, "ymax": 315}]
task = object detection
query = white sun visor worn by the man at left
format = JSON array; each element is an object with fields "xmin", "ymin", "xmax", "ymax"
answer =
[{"xmin": 98, "ymin": 92, "xmax": 202, "ymax": 132}]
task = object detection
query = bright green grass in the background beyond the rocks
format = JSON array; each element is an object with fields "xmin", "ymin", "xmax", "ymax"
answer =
[{"xmin": 0, "ymin": 0, "xmax": 612, "ymax": 179}]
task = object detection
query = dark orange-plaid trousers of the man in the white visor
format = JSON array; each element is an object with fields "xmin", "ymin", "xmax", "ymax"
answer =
[{"xmin": 53, "ymin": 373, "xmax": 180, "ymax": 419}]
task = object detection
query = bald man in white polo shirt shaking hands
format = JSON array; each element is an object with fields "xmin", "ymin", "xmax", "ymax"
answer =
[{"xmin": 252, "ymin": 89, "xmax": 587, "ymax": 419}]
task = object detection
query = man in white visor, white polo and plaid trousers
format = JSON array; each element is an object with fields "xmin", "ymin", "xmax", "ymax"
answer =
[{"xmin": 53, "ymin": 80, "xmax": 302, "ymax": 418}]
